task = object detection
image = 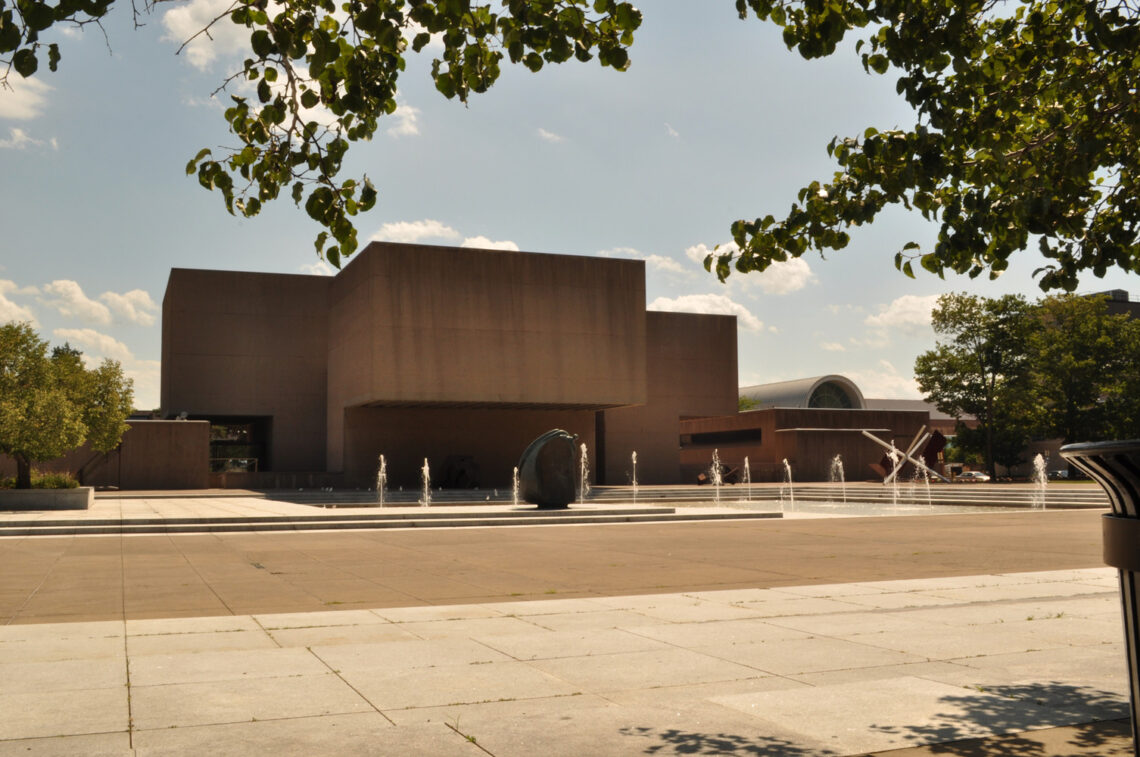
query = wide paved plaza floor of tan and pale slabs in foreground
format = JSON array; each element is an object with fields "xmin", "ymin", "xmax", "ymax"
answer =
[{"xmin": 0, "ymin": 498, "xmax": 1131, "ymax": 757}]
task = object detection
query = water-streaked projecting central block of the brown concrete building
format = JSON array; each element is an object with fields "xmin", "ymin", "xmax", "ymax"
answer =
[{"xmin": 326, "ymin": 243, "xmax": 646, "ymax": 471}]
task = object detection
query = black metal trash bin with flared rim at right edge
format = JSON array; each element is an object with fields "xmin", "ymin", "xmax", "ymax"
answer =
[{"xmin": 1061, "ymin": 439, "xmax": 1140, "ymax": 757}]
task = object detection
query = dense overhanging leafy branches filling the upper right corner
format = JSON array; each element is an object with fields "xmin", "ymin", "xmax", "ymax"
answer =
[{"xmin": 705, "ymin": 0, "xmax": 1140, "ymax": 291}]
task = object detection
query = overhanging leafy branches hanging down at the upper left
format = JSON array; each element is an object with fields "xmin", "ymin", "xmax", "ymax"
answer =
[{"xmin": 0, "ymin": 0, "xmax": 642, "ymax": 267}]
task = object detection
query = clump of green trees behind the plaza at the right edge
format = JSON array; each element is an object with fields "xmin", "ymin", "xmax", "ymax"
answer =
[{"xmin": 914, "ymin": 294, "xmax": 1140, "ymax": 474}]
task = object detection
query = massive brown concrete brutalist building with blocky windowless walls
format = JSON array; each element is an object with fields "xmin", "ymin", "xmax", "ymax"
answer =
[{"xmin": 162, "ymin": 243, "xmax": 736, "ymax": 488}]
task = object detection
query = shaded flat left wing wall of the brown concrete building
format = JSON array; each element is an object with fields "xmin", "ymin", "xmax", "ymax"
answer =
[{"xmin": 162, "ymin": 268, "xmax": 332, "ymax": 471}]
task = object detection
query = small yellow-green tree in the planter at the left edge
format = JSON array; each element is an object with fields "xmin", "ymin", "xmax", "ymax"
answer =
[{"xmin": 0, "ymin": 323, "xmax": 133, "ymax": 489}]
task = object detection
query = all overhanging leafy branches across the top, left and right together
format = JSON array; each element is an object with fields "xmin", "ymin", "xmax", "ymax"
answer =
[{"xmin": 0, "ymin": 0, "xmax": 1140, "ymax": 291}]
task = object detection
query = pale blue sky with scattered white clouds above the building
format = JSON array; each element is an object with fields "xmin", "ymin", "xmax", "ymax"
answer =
[{"xmin": 0, "ymin": 0, "xmax": 1140, "ymax": 408}]
